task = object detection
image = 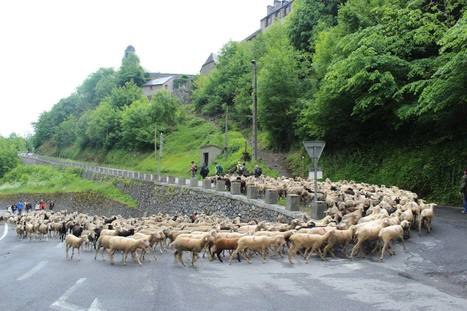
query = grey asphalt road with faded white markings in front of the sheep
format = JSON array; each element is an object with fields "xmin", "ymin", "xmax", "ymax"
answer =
[{"xmin": 0, "ymin": 209, "xmax": 467, "ymax": 311}]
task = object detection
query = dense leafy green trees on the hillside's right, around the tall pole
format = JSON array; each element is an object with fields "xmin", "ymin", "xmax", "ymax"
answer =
[{"xmin": 193, "ymin": 0, "xmax": 467, "ymax": 203}]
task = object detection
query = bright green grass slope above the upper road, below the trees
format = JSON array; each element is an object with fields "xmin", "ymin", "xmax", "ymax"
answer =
[{"xmin": 38, "ymin": 113, "xmax": 278, "ymax": 177}]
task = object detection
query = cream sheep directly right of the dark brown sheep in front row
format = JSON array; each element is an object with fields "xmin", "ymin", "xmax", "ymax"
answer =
[{"xmin": 229, "ymin": 236, "xmax": 285, "ymax": 264}]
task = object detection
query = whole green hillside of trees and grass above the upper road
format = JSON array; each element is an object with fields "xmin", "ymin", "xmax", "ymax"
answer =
[{"xmin": 34, "ymin": 0, "xmax": 467, "ymax": 204}]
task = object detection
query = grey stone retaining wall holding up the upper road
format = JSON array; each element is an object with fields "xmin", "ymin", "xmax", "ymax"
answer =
[{"xmin": 14, "ymin": 156, "xmax": 303, "ymax": 221}]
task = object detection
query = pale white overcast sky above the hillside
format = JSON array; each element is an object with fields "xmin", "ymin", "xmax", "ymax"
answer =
[{"xmin": 0, "ymin": 0, "xmax": 273, "ymax": 136}]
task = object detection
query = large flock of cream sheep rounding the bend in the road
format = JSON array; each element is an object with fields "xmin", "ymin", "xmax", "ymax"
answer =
[{"xmin": 0, "ymin": 179, "xmax": 435, "ymax": 265}]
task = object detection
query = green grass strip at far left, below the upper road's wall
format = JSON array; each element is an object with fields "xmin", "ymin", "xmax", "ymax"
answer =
[{"xmin": 0, "ymin": 165, "xmax": 138, "ymax": 207}]
